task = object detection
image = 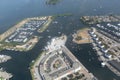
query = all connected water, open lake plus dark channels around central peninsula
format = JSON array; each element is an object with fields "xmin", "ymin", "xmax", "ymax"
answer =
[{"xmin": 0, "ymin": 0, "xmax": 120, "ymax": 80}]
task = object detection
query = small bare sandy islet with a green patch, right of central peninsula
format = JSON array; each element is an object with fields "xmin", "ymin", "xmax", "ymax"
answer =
[{"xmin": 73, "ymin": 28, "xmax": 91, "ymax": 44}]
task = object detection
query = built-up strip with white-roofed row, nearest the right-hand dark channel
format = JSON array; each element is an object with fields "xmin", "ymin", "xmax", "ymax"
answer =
[{"xmin": 90, "ymin": 28, "xmax": 120, "ymax": 76}]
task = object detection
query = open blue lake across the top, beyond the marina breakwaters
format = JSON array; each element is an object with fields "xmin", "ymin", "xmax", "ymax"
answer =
[{"xmin": 0, "ymin": 0, "xmax": 120, "ymax": 33}]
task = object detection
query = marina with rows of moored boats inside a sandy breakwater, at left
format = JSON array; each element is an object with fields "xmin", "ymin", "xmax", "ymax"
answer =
[{"xmin": 0, "ymin": 16, "xmax": 52, "ymax": 51}]
